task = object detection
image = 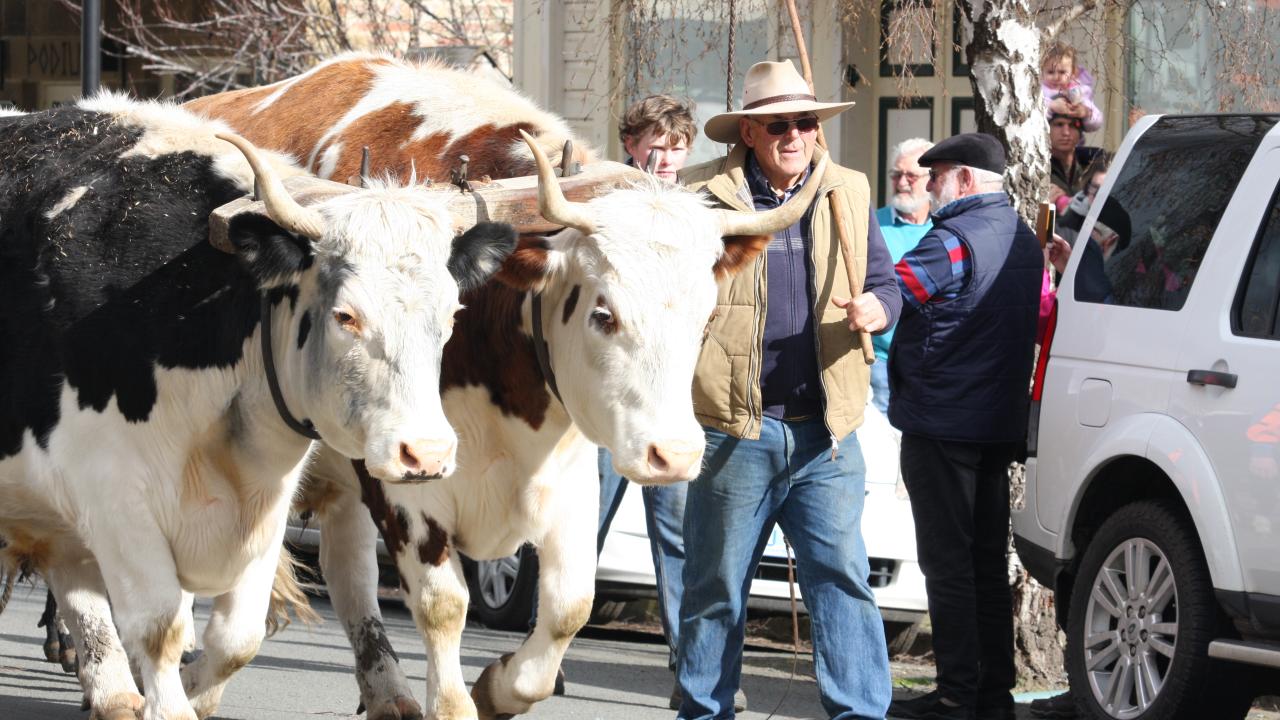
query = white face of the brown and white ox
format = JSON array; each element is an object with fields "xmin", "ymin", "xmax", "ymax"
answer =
[{"xmin": 535, "ymin": 178, "xmax": 723, "ymax": 484}]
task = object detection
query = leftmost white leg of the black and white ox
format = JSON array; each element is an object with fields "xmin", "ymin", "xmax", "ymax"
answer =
[{"xmin": 46, "ymin": 561, "xmax": 143, "ymax": 720}]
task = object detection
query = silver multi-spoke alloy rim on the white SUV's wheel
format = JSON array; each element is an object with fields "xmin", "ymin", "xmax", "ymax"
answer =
[{"xmin": 1083, "ymin": 538, "xmax": 1178, "ymax": 720}]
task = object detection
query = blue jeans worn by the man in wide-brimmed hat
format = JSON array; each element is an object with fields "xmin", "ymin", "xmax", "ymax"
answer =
[{"xmin": 676, "ymin": 418, "xmax": 892, "ymax": 720}]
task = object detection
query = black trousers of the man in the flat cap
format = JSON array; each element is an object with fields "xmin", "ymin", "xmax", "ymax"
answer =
[{"xmin": 902, "ymin": 433, "xmax": 1016, "ymax": 706}]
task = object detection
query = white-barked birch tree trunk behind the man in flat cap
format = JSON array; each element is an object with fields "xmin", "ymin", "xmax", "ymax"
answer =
[{"xmin": 959, "ymin": 0, "xmax": 1064, "ymax": 685}]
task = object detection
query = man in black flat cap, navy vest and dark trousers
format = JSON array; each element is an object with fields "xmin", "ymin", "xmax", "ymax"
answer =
[{"xmin": 888, "ymin": 133, "xmax": 1044, "ymax": 720}]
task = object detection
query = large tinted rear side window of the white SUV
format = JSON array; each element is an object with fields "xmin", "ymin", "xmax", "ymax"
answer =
[{"xmin": 1075, "ymin": 115, "xmax": 1276, "ymax": 310}]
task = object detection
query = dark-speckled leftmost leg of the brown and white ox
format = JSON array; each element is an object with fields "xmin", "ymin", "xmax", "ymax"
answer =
[{"xmin": 320, "ymin": 493, "xmax": 422, "ymax": 720}]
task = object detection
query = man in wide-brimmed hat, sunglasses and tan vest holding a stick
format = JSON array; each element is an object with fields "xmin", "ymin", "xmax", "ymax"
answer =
[{"xmin": 677, "ymin": 61, "xmax": 902, "ymax": 719}]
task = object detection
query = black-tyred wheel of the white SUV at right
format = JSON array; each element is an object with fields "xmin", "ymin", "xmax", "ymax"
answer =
[{"xmin": 1066, "ymin": 501, "xmax": 1252, "ymax": 720}]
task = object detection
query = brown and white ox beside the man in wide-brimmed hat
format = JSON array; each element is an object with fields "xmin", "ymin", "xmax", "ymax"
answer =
[{"xmin": 192, "ymin": 58, "xmax": 820, "ymax": 719}]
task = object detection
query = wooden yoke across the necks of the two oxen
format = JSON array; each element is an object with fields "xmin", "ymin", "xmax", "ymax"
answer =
[{"xmin": 216, "ymin": 160, "xmax": 644, "ymax": 252}]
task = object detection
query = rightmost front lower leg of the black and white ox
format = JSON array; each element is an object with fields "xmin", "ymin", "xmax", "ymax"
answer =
[{"xmin": 178, "ymin": 553, "xmax": 279, "ymax": 717}]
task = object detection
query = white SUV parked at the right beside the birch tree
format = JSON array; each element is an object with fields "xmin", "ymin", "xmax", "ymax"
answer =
[{"xmin": 1014, "ymin": 115, "xmax": 1280, "ymax": 720}]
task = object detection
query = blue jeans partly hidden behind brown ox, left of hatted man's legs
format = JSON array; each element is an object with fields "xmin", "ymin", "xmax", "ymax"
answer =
[{"xmin": 595, "ymin": 447, "xmax": 689, "ymax": 670}]
